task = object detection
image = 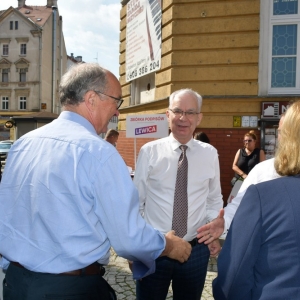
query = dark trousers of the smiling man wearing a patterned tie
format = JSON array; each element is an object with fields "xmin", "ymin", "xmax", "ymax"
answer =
[{"xmin": 136, "ymin": 243, "xmax": 209, "ymax": 300}]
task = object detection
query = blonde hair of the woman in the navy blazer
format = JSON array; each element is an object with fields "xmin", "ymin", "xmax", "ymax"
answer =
[{"xmin": 274, "ymin": 101, "xmax": 300, "ymax": 176}]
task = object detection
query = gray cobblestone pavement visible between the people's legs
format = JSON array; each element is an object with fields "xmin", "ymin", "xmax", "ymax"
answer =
[{"xmin": 104, "ymin": 250, "xmax": 217, "ymax": 300}]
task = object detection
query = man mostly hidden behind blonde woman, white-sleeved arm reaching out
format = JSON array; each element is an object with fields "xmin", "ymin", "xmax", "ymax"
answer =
[{"xmin": 197, "ymin": 114, "xmax": 284, "ymax": 244}]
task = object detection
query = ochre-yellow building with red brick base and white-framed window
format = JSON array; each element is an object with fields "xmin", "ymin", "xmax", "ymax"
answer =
[{"xmin": 118, "ymin": 0, "xmax": 300, "ymax": 203}]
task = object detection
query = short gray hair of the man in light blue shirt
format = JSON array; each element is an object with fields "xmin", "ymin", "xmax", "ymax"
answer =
[{"xmin": 59, "ymin": 63, "xmax": 107, "ymax": 106}]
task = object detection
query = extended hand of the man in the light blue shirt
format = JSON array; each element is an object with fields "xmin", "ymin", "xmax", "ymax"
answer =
[{"xmin": 160, "ymin": 230, "xmax": 192, "ymax": 263}]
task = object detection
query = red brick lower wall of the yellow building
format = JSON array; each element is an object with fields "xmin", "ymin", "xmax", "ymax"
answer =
[{"xmin": 117, "ymin": 128, "xmax": 260, "ymax": 205}]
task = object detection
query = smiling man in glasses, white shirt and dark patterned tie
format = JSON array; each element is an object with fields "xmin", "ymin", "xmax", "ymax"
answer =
[{"xmin": 133, "ymin": 89, "xmax": 223, "ymax": 300}]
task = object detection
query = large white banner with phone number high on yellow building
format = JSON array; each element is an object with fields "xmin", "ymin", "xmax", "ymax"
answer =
[{"xmin": 126, "ymin": 0, "xmax": 162, "ymax": 82}]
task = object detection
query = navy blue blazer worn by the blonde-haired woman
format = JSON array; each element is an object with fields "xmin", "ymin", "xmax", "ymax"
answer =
[{"xmin": 213, "ymin": 175, "xmax": 300, "ymax": 300}]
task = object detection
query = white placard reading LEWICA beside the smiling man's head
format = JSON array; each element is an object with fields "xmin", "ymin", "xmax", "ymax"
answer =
[{"xmin": 126, "ymin": 114, "xmax": 169, "ymax": 138}]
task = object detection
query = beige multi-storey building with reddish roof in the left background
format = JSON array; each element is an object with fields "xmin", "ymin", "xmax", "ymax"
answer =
[{"xmin": 0, "ymin": 0, "xmax": 67, "ymax": 139}]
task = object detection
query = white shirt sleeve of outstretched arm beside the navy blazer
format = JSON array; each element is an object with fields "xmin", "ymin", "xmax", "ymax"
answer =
[{"xmin": 221, "ymin": 158, "xmax": 280, "ymax": 238}]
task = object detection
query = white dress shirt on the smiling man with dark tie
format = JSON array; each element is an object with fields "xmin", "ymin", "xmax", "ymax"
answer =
[{"xmin": 134, "ymin": 133, "xmax": 223, "ymax": 241}]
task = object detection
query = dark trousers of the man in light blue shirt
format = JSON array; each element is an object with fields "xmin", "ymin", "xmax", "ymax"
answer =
[{"xmin": 3, "ymin": 264, "xmax": 112, "ymax": 300}]
